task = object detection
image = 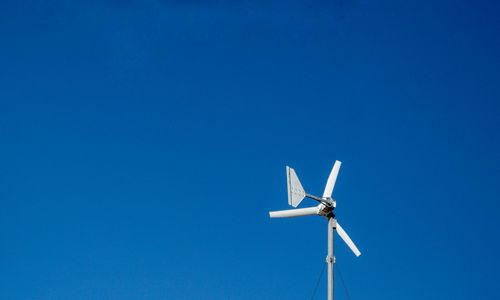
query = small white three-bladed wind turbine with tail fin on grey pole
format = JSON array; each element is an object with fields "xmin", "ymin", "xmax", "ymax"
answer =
[{"xmin": 269, "ymin": 160, "xmax": 361, "ymax": 300}]
